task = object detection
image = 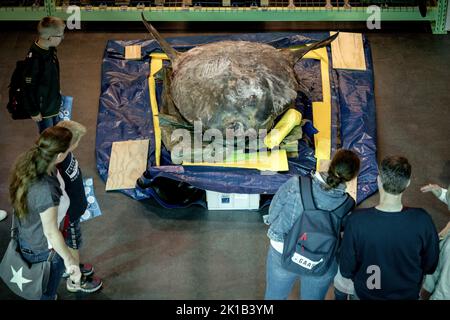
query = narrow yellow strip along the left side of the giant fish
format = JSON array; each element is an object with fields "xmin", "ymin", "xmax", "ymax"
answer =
[{"xmin": 148, "ymin": 53, "xmax": 169, "ymax": 166}]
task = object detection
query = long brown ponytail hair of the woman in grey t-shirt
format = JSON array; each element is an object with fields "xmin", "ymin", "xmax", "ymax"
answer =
[{"xmin": 9, "ymin": 127, "xmax": 72, "ymax": 218}]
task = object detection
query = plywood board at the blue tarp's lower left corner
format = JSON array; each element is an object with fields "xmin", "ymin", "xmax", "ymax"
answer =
[{"xmin": 106, "ymin": 139, "xmax": 149, "ymax": 191}]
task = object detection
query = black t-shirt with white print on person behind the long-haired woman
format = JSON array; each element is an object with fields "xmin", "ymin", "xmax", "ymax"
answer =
[{"xmin": 58, "ymin": 152, "xmax": 88, "ymax": 222}]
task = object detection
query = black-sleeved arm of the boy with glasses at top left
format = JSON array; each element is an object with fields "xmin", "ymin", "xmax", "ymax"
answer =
[{"xmin": 22, "ymin": 58, "xmax": 42, "ymax": 121}]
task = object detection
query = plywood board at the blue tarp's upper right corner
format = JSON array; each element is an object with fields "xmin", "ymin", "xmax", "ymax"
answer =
[{"xmin": 330, "ymin": 31, "xmax": 366, "ymax": 70}]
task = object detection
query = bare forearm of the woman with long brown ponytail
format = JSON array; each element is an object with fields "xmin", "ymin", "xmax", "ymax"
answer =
[{"xmin": 40, "ymin": 207, "xmax": 81, "ymax": 283}]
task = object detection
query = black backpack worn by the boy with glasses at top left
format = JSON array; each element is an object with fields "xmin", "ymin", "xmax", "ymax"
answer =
[{"xmin": 6, "ymin": 58, "xmax": 30, "ymax": 120}]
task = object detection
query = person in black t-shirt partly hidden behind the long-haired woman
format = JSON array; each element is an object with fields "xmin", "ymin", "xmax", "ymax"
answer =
[{"xmin": 57, "ymin": 121, "xmax": 102, "ymax": 293}]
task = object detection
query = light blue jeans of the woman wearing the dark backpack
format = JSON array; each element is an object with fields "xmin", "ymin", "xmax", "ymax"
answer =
[{"xmin": 265, "ymin": 245, "xmax": 338, "ymax": 300}]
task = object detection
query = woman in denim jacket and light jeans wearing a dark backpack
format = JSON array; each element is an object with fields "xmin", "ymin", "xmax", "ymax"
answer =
[{"xmin": 265, "ymin": 149, "xmax": 360, "ymax": 300}]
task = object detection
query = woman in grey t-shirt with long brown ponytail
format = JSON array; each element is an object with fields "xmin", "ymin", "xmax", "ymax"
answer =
[{"xmin": 9, "ymin": 127, "xmax": 81, "ymax": 300}]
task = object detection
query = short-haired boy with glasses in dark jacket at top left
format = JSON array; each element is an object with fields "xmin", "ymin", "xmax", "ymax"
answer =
[{"xmin": 22, "ymin": 17, "xmax": 65, "ymax": 133}]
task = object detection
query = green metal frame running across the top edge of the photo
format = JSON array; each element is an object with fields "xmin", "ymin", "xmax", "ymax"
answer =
[{"xmin": 0, "ymin": 0, "xmax": 449, "ymax": 34}]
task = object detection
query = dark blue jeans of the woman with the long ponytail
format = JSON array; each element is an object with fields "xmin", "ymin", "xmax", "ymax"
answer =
[{"xmin": 19, "ymin": 240, "xmax": 66, "ymax": 300}]
